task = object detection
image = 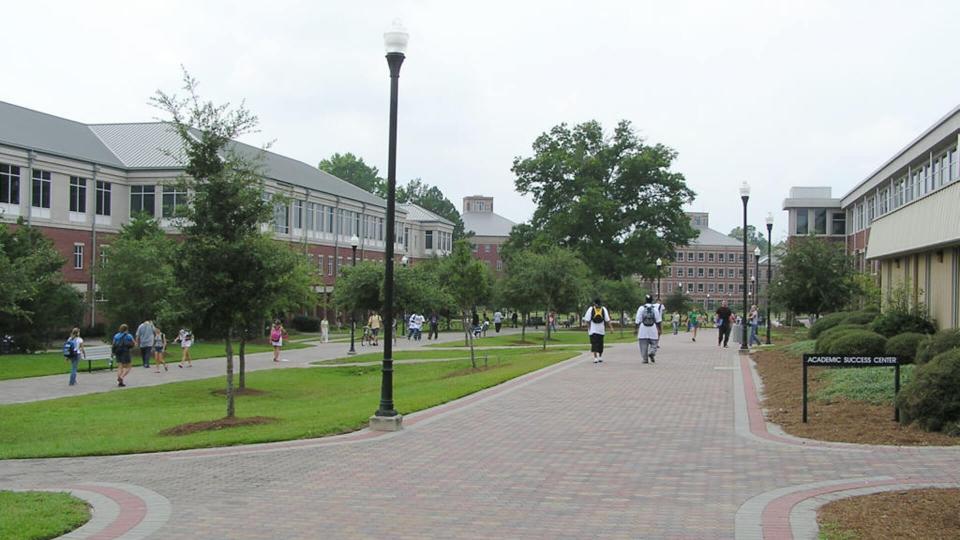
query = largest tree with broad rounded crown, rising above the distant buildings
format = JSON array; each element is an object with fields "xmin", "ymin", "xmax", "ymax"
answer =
[{"xmin": 512, "ymin": 121, "xmax": 697, "ymax": 279}]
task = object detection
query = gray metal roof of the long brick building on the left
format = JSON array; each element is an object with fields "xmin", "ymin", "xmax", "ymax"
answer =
[{"xmin": 0, "ymin": 101, "xmax": 387, "ymax": 207}]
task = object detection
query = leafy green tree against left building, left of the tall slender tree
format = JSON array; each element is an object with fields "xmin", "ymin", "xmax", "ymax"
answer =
[{"xmin": 98, "ymin": 214, "xmax": 184, "ymax": 328}]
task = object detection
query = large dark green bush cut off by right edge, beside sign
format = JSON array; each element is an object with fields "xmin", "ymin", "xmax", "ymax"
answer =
[{"xmin": 897, "ymin": 349, "xmax": 960, "ymax": 431}]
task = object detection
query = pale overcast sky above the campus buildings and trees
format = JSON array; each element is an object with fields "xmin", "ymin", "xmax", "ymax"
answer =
[{"xmin": 0, "ymin": 0, "xmax": 960, "ymax": 239}]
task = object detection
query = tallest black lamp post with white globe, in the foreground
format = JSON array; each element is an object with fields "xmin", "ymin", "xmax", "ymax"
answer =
[{"xmin": 370, "ymin": 20, "xmax": 410, "ymax": 431}]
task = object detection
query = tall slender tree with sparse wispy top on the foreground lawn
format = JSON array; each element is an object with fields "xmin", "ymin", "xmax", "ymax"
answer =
[{"xmin": 152, "ymin": 72, "xmax": 273, "ymax": 418}]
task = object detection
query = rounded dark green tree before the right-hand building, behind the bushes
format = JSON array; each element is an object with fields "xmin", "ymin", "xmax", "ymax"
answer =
[{"xmin": 770, "ymin": 236, "xmax": 857, "ymax": 317}]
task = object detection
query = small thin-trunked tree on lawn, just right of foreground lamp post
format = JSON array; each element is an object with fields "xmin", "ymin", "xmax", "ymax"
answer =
[{"xmin": 440, "ymin": 239, "xmax": 491, "ymax": 368}]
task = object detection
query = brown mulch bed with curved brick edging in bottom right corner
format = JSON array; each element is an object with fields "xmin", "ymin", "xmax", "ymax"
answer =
[{"xmin": 817, "ymin": 489, "xmax": 960, "ymax": 540}]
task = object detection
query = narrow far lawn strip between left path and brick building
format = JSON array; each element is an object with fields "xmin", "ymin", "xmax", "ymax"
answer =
[{"xmin": 0, "ymin": 340, "xmax": 310, "ymax": 381}]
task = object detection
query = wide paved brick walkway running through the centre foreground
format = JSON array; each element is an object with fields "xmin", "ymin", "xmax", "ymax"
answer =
[{"xmin": 0, "ymin": 336, "xmax": 960, "ymax": 538}]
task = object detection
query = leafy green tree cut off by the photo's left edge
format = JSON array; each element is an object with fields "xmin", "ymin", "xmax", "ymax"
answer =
[{"xmin": 0, "ymin": 218, "xmax": 83, "ymax": 351}]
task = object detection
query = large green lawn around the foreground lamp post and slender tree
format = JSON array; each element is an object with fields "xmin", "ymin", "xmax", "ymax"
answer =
[{"xmin": 0, "ymin": 350, "xmax": 579, "ymax": 458}]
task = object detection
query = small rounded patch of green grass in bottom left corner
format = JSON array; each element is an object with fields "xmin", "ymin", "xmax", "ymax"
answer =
[{"xmin": 0, "ymin": 491, "xmax": 90, "ymax": 540}]
